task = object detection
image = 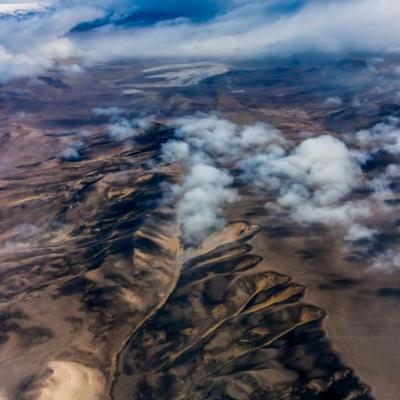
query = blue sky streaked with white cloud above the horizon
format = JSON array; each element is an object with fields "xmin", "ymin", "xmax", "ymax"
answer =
[{"xmin": 0, "ymin": 0, "xmax": 400, "ymax": 81}]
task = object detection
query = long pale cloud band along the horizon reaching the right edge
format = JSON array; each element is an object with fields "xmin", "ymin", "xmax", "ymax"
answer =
[{"xmin": 76, "ymin": 0, "xmax": 400, "ymax": 60}]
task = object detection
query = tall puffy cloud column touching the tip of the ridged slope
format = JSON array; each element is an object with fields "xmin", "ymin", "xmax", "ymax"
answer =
[{"xmin": 162, "ymin": 114, "xmax": 285, "ymax": 246}]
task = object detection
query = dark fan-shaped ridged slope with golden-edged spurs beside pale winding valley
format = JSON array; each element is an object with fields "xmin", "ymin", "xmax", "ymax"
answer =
[{"xmin": 113, "ymin": 223, "xmax": 370, "ymax": 400}]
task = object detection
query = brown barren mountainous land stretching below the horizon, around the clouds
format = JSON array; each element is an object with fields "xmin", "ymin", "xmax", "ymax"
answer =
[{"xmin": 0, "ymin": 59, "xmax": 400, "ymax": 400}]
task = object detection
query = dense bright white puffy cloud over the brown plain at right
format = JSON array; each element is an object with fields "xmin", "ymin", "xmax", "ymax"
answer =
[{"xmin": 239, "ymin": 135, "xmax": 370, "ymax": 227}]
